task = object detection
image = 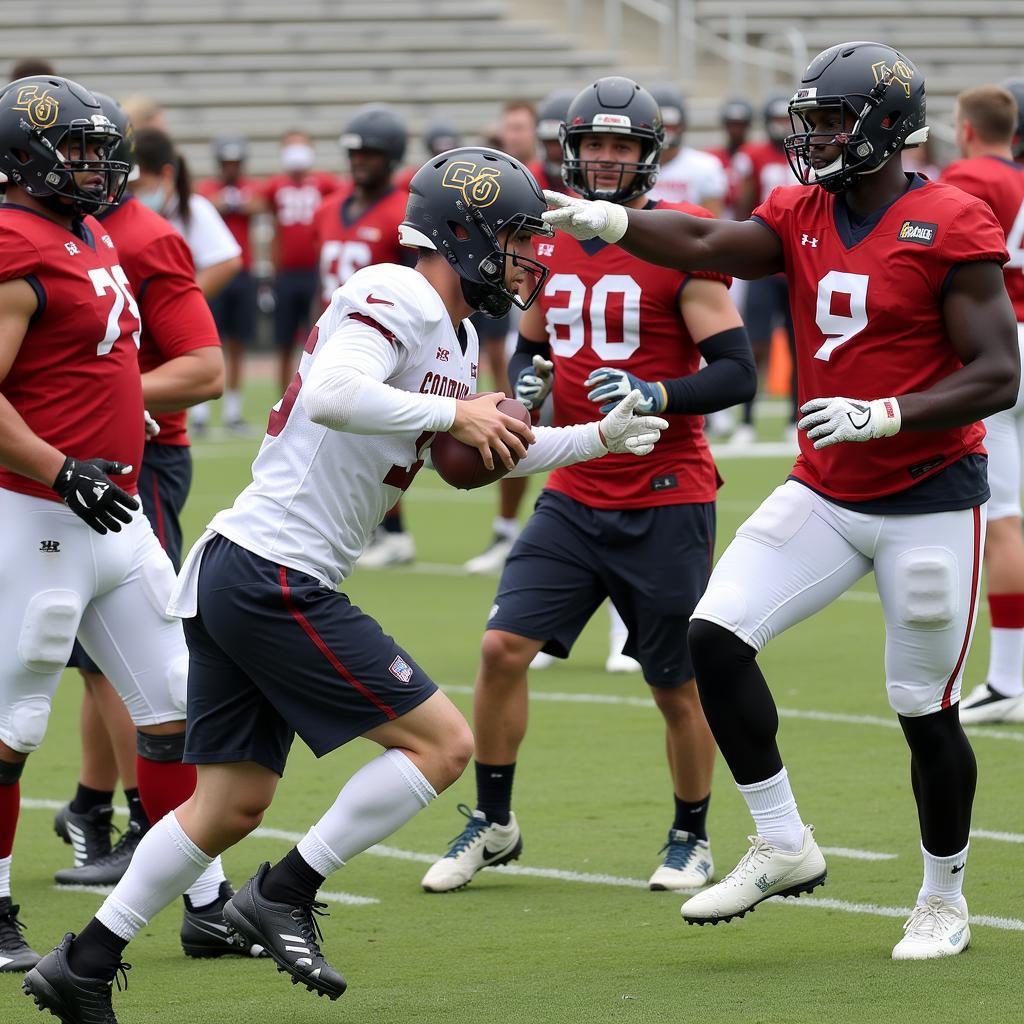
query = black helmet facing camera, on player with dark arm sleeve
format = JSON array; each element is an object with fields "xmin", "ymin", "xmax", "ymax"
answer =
[{"xmin": 561, "ymin": 76, "xmax": 665, "ymax": 203}]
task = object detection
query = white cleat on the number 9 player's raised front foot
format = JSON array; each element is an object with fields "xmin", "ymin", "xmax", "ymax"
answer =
[{"xmin": 680, "ymin": 825, "xmax": 828, "ymax": 925}]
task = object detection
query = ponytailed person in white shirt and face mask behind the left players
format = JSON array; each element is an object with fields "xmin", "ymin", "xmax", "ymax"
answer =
[{"xmin": 129, "ymin": 128, "xmax": 242, "ymax": 436}]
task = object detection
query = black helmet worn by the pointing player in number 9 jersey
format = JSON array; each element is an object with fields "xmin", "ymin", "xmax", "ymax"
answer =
[{"xmin": 785, "ymin": 42, "xmax": 928, "ymax": 193}]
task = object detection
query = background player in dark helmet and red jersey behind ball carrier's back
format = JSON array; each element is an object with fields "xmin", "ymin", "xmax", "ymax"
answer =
[{"xmin": 313, "ymin": 104, "xmax": 416, "ymax": 568}]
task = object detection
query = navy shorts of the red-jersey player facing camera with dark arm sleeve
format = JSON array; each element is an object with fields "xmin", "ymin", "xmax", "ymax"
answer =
[{"xmin": 487, "ymin": 490, "xmax": 715, "ymax": 686}]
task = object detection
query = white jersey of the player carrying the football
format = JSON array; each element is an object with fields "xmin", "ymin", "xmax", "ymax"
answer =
[{"xmin": 210, "ymin": 263, "xmax": 478, "ymax": 587}]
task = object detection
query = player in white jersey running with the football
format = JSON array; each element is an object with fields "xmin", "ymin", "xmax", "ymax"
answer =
[{"xmin": 25, "ymin": 147, "xmax": 667, "ymax": 1022}]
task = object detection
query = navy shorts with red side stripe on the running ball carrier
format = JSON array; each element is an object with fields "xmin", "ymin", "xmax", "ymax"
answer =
[{"xmin": 184, "ymin": 537, "xmax": 437, "ymax": 775}]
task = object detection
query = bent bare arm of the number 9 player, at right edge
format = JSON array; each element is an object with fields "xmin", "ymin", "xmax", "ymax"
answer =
[{"xmin": 899, "ymin": 261, "xmax": 1021, "ymax": 430}]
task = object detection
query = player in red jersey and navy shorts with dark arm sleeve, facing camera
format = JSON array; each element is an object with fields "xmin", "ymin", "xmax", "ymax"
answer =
[{"xmin": 423, "ymin": 77, "xmax": 756, "ymax": 892}]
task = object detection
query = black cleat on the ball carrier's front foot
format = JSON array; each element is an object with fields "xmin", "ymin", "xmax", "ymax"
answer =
[{"xmin": 223, "ymin": 861, "xmax": 346, "ymax": 999}]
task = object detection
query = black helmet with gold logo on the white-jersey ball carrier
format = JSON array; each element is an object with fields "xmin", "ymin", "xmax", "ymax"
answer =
[{"xmin": 398, "ymin": 145, "xmax": 553, "ymax": 316}]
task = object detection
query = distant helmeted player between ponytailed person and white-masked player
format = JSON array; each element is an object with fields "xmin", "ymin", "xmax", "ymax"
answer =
[{"xmin": 194, "ymin": 135, "xmax": 260, "ymax": 434}]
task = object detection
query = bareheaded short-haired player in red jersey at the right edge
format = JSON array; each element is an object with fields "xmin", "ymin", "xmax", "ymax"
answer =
[{"xmin": 941, "ymin": 85, "xmax": 1024, "ymax": 722}]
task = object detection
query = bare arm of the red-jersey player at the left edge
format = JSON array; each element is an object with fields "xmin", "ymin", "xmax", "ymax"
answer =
[{"xmin": 0, "ymin": 280, "xmax": 65, "ymax": 486}]
